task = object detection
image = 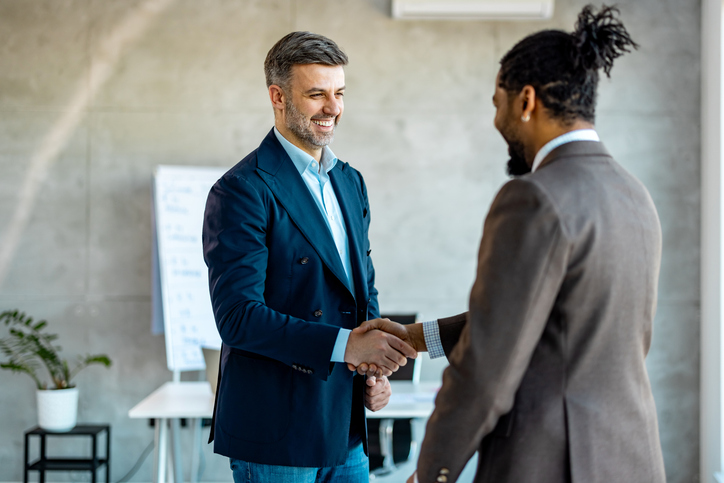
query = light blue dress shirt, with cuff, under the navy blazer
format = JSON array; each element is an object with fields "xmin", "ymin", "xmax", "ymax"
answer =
[{"xmin": 274, "ymin": 127, "xmax": 354, "ymax": 362}]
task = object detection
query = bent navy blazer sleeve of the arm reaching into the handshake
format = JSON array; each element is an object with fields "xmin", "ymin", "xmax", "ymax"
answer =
[{"xmin": 203, "ymin": 174, "xmax": 339, "ymax": 380}]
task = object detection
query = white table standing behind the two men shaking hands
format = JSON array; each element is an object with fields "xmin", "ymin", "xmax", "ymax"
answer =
[{"xmin": 128, "ymin": 381, "xmax": 440, "ymax": 483}]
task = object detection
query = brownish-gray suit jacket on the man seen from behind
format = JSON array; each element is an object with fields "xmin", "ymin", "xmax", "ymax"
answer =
[{"xmin": 418, "ymin": 141, "xmax": 665, "ymax": 483}]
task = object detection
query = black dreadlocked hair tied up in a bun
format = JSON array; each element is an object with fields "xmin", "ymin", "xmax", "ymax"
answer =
[{"xmin": 500, "ymin": 5, "xmax": 638, "ymax": 124}]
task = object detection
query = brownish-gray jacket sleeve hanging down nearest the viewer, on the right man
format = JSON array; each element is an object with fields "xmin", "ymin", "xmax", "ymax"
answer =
[{"xmin": 418, "ymin": 179, "xmax": 569, "ymax": 483}]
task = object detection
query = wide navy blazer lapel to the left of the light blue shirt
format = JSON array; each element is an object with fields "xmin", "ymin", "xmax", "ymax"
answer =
[{"xmin": 256, "ymin": 129, "xmax": 354, "ymax": 295}]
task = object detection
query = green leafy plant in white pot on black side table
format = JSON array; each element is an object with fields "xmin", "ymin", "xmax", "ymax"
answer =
[{"xmin": 0, "ymin": 310, "xmax": 111, "ymax": 432}]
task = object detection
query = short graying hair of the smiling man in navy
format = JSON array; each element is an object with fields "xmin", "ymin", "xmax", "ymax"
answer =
[{"xmin": 264, "ymin": 32, "xmax": 347, "ymax": 89}]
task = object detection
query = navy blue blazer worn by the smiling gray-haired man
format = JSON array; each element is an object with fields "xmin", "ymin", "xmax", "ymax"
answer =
[{"xmin": 203, "ymin": 126, "xmax": 379, "ymax": 467}]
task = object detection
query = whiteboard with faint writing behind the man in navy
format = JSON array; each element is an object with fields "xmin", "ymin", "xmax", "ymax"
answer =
[{"xmin": 153, "ymin": 166, "xmax": 226, "ymax": 371}]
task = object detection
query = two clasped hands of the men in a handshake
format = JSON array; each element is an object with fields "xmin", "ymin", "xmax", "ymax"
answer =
[{"xmin": 344, "ymin": 319, "xmax": 427, "ymax": 378}]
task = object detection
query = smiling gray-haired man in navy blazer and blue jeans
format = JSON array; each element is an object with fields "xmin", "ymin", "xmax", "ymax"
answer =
[{"xmin": 203, "ymin": 32, "xmax": 416, "ymax": 483}]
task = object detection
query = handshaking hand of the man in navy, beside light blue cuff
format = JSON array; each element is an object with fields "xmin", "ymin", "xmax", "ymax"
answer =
[{"xmin": 344, "ymin": 329, "xmax": 417, "ymax": 376}]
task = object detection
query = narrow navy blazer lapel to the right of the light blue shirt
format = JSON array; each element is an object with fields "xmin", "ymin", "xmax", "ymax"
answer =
[{"xmin": 329, "ymin": 165, "xmax": 367, "ymax": 300}]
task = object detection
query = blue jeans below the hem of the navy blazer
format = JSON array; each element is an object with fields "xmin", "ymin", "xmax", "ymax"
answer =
[{"xmin": 229, "ymin": 443, "xmax": 370, "ymax": 483}]
